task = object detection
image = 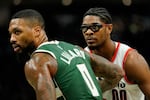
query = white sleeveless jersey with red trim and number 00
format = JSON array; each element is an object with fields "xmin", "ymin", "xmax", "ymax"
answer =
[{"xmin": 85, "ymin": 42, "xmax": 144, "ymax": 100}]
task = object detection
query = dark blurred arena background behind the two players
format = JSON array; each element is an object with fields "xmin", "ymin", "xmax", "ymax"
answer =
[{"xmin": 0, "ymin": 0, "xmax": 150, "ymax": 100}]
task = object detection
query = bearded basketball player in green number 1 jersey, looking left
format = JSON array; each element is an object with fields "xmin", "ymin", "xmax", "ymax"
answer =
[{"xmin": 8, "ymin": 9, "xmax": 124, "ymax": 100}]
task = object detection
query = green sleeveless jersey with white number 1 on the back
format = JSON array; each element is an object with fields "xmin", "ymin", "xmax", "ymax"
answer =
[{"xmin": 35, "ymin": 41, "xmax": 102, "ymax": 100}]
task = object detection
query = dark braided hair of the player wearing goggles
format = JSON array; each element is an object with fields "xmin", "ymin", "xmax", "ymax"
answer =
[{"xmin": 83, "ymin": 7, "xmax": 112, "ymax": 24}]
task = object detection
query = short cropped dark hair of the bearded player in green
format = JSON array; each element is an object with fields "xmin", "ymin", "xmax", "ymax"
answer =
[{"xmin": 11, "ymin": 9, "xmax": 45, "ymax": 28}]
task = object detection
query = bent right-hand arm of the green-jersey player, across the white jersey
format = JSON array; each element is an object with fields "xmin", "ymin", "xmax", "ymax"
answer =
[{"xmin": 92, "ymin": 55, "xmax": 124, "ymax": 91}]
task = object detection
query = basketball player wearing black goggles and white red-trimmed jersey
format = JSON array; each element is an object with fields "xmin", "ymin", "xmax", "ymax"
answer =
[{"xmin": 81, "ymin": 8, "xmax": 150, "ymax": 100}]
